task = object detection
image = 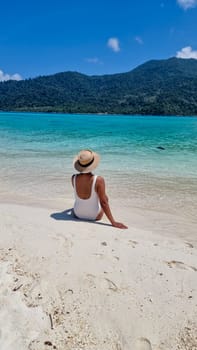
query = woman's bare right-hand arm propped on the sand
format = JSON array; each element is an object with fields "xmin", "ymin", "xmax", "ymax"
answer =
[{"xmin": 96, "ymin": 176, "xmax": 128, "ymax": 228}]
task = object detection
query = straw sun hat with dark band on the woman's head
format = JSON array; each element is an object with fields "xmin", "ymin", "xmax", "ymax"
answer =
[{"xmin": 73, "ymin": 149, "xmax": 100, "ymax": 174}]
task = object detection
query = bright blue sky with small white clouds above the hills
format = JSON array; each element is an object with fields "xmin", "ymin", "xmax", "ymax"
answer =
[{"xmin": 0, "ymin": 0, "xmax": 197, "ymax": 81}]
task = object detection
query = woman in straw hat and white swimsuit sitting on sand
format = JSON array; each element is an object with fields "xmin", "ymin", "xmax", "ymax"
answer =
[{"xmin": 72, "ymin": 150, "xmax": 127, "ymax": 228}]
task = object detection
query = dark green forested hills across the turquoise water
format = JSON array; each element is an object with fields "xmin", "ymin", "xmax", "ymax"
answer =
[{"xmin": 0, "ymin": 58, "xmax": 197, "ymax": 115}]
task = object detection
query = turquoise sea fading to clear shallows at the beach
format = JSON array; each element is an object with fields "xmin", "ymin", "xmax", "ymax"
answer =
[{"xmin": 0, "ymin": 112, "xmax": 197, "ymax": 235}]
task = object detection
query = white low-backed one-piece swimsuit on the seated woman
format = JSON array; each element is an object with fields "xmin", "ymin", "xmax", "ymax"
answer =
[{"xmin": 73, "ymin": 175, "xmax": 101, "ymax": 220}]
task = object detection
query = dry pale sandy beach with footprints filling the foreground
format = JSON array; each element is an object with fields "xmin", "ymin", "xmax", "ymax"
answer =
[{"xmin": 0, "ymin": 203, "xmax": 197, "ymax": 350}]
